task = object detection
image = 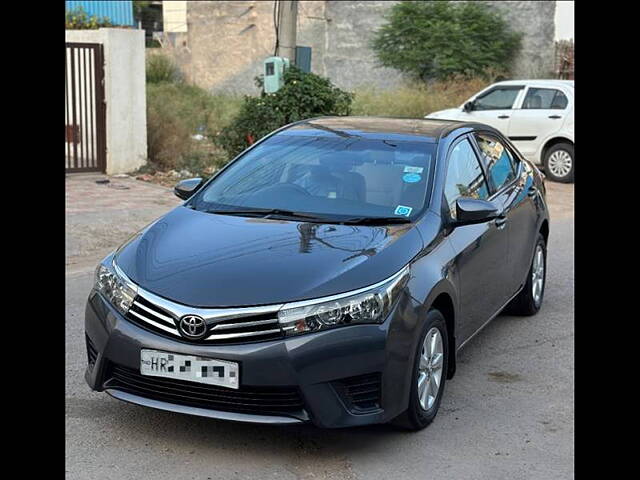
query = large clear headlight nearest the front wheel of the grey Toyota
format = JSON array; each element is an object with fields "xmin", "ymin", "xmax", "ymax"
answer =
[{"xmin": 278, "ymin": 266, "xmax": 410, "ymax": 335}]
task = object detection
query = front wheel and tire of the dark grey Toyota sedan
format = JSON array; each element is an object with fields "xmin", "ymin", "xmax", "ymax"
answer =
[{"xmin": 393, "ymin": 309, "xmax": 449, "ymax": 431}]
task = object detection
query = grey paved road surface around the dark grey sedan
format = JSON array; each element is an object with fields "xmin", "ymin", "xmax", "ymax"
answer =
[{"xmin": 66, "ymin": 176, "xmax": 574, "ymax": 480}]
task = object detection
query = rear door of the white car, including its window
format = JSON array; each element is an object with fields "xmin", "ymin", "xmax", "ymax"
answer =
[{"xmin": 508, "ymin": 86, "xmax": 573, "ymax": 163}]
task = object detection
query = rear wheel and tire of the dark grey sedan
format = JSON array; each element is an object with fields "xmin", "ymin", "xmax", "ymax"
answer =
[{"xmin": 504, "ymin": 234, "xmax": 547, "ymax": 315}]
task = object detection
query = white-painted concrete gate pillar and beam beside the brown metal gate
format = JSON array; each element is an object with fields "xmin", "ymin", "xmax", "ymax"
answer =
[{"xmin": 65, "ymin": 28, "xmax": 147, "ymax": 175}]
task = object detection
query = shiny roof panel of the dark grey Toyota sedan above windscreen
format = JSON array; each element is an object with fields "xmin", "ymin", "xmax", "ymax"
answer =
[{"xmin": 279, "ymin": 116, "xmax": 484, "ymax": 143}]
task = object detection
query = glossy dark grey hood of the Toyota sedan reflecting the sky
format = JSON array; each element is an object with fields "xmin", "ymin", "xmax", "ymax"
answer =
[{"xmin": 115, "ymin": 206, "xmax": 423, "ymax": 307}]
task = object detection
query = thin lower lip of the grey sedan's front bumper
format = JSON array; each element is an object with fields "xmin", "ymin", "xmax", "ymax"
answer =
[{"xmin": 104, "ymin": 388, "xmax": 309, "ymax": 425}]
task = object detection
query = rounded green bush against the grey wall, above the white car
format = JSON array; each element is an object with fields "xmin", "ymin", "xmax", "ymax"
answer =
[{"xmin": 371, "ymin": 1, "xmax": 521, "ymax": 81}]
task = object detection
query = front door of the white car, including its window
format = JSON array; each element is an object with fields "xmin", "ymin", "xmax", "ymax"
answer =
[{"xmin": 465, "ymin": 85, "xmax": 524, "ymax": 135}]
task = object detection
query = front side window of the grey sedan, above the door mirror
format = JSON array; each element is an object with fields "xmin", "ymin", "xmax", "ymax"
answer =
[{"xmin": 444, "ymin": 139, "xmax": 489, "ymax": 218}]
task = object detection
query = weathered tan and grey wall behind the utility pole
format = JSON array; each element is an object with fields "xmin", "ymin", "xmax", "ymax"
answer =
[{"xmin": 154, "ymin": 0, "xmax": 556, "ymax": 94}]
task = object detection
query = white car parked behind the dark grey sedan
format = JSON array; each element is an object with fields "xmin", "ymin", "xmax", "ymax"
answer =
[{"xmin": 425, "ymin": 80, "xmax": 575, "ymax": 183}]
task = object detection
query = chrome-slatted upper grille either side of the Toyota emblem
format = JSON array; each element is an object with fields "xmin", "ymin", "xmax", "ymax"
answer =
[{"xmin": 126, "ymin": 295, "xmax": 284, "ymax": 345}]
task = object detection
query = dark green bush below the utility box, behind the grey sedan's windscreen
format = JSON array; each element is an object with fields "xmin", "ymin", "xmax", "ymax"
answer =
[{"xmin": 215, "ymin": 67, "xmax": 353, "ymax": 158}]
